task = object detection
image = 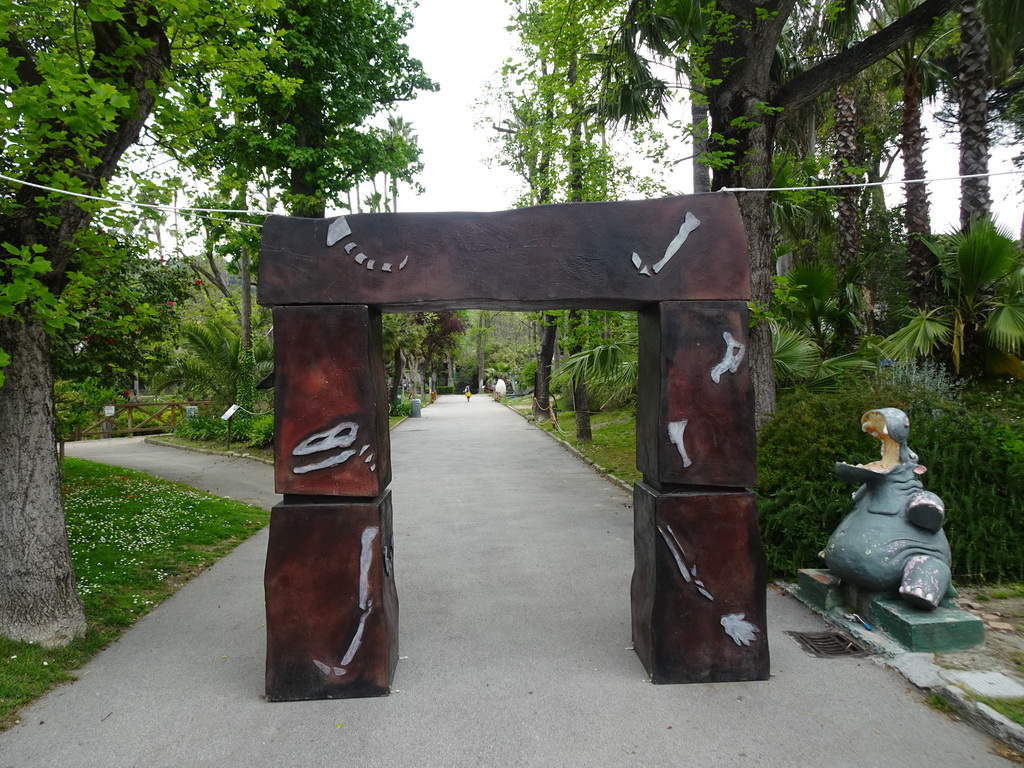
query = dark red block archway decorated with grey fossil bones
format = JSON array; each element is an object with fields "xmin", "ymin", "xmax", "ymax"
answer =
[{"xmin": 259, "ymin": 195, "xmax": 768, "ymax": 700}]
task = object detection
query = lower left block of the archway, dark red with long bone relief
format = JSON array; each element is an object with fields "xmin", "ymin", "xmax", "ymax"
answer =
[{"xmin": 264, "ymin": 492, "xmax": 398, "ymax": 701}]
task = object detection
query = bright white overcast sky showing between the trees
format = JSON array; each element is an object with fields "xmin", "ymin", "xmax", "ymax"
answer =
[{"xmin": 387, "ymin": 0, "xmax": 1024, "ymax": 234}]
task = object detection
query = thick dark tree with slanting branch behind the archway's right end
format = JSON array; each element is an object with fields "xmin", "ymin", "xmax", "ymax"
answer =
[{"xmin": 598, "ymin": 0, "xmax": 958, "ymax": 428}]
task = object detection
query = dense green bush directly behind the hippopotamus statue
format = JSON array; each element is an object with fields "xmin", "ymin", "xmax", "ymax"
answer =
[{"xmin": 758, "ymin": 381, "xmax": 1024, "ymax": 581}]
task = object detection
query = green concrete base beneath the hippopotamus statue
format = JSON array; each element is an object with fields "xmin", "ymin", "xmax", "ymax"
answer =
[{"xmin": 797, "ymin": 568, "xmax": 985, "ymax": 652}]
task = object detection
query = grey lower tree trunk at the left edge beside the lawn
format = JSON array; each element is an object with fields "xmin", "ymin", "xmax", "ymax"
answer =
[{"xmin": 0, "ymin": 319, "xmax": 85, "ymax": 647}]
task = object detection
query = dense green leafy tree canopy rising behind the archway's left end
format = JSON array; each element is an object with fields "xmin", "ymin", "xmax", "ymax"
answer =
[{"xmin": 189, "ymin": 0, "xmax": 437, "ymax": 216}]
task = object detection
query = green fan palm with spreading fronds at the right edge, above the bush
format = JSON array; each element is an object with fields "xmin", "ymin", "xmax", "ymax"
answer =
[{"xmin": 882, "ymin": 219, "xmax": 1024, "ymax": 374}]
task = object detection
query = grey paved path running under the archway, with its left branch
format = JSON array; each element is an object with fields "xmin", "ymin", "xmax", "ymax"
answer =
[{"xmin": 0, "ymin": 396, "xmax": 1009, "ymax": 768}]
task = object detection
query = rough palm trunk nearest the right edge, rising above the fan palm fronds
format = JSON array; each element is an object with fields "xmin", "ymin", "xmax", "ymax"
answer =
[{"xmin": 956, "ymin": 0, "xmax": 992, "ymax": 229}]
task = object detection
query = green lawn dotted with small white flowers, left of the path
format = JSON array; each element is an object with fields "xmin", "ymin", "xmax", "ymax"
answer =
[{"xmin": 0, "ymin": 458, "xmax": 270, "ymax": 731}]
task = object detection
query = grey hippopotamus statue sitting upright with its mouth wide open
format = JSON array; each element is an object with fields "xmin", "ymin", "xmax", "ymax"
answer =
[{"xmin": 823, "ymin": 408, "xmax": 951, "ymax": 609}]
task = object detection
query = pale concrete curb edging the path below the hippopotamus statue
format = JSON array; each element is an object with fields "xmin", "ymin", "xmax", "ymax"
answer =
[{"xmin": 775, "ymin": 582, "xmax": 1024, "ymax": 753}]
